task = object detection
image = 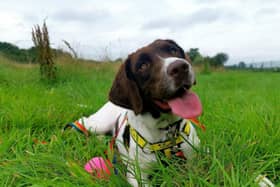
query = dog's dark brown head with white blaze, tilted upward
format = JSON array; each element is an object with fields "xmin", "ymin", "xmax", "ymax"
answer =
[{"xmin": 109, "ymin": 40, "xmax": 201, "ymax": 117}]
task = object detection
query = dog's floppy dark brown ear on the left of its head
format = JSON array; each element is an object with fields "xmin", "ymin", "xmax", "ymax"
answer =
[{"xmin": 109, "ymin": 57, "xmax": 143, "ymax": 114}]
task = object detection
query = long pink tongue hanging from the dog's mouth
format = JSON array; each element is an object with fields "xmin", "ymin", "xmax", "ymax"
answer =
[{"xmin": 168, "ymin": 91, "xmax": 202, "ymax": 119}]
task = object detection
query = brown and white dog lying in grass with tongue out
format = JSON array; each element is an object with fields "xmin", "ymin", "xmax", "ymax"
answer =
[{"xmin": 71, "ymin": 39, "xmax": 202, "ymax": 186}]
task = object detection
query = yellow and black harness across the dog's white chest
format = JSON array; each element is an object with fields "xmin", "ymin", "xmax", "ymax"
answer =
[{"xmin": 130, "ymin": 120, "xmax": 193, "ymax": 158}]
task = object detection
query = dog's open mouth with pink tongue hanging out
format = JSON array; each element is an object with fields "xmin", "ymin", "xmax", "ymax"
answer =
[{"xmin": 154, "ymin": 89, "xmax": 202, "ymax": 119}]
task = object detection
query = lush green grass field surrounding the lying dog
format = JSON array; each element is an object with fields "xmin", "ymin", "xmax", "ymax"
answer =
[{"xmin": 0, "ymin": 57, "xmax": 280, "ymax": 186}]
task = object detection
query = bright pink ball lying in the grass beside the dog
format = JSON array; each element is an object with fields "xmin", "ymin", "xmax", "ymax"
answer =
[{"xmin": 85, "ymin": 157, "xmax": 113, "ymax": 178}]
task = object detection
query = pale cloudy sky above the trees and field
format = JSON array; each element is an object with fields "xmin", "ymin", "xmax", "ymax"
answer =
[{"xmin": 0, "ymin": 0, "xmax": 280, "ymax": 64}]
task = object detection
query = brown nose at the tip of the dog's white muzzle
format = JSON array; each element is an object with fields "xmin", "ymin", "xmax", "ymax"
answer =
[{"xmin": 167, "ymin": 60, "xmax": 189, "ymax": 78}]
